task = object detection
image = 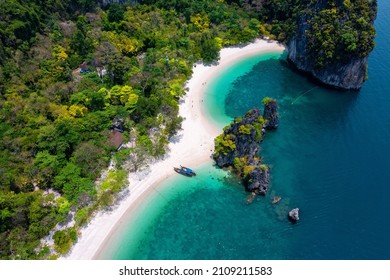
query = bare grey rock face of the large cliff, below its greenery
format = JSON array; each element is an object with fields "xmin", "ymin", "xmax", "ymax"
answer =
[{"xmin": 288, "ymin": 0, "xmax": 377, "ymax": 90}]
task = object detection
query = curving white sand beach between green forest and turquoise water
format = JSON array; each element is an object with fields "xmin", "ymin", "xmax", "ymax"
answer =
[{"xmin": 61, "ymin": 40, "xmax": 285, "ymax": 260}]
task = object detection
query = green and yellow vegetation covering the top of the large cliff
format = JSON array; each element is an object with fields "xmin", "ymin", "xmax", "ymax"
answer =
[{"xmin": 304, "ymin": 0, "xmax": 377, "ymax": 68}]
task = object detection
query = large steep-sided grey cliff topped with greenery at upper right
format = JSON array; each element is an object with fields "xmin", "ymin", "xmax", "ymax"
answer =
[{"xmin": 288, "ymin": 0, "xmax": 377, "ymax": 90}]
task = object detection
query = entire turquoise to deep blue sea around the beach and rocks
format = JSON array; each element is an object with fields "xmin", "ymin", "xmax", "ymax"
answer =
[{"xmin": 102, "ymin": 0, "xmax": 390, "ymax": 260}]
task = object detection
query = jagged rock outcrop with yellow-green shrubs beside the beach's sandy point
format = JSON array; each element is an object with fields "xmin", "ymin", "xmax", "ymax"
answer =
[{"xmin": 213, "ymin": 98, "xmax": 278, "ymax": 195}]
